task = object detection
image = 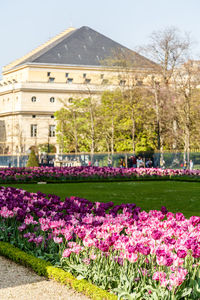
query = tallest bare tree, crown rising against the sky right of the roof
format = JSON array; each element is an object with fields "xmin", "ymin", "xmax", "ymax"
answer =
[{"xmin": 142, "ymin": 27, "xmax": 191, "ymax": 160}]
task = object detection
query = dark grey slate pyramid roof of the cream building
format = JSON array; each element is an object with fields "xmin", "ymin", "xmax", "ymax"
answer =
[{"xmin": 16, "ymin": 26, "xmax": 154, "ymax": 68}]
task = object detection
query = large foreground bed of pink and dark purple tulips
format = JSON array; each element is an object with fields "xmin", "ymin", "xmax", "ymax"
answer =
[{"xmin": 0, "ymin": 187, "xmax": 200, "ymax": 299}]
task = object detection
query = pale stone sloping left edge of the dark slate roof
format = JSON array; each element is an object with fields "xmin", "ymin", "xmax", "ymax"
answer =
[{"xmin": 3, "ymin": 27, "xmax": 75, "ymax": 72}]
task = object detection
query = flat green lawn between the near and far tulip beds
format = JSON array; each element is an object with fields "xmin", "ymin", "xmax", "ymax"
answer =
[{"xmin": 1, "ymin": 181, "xmax": 200, "ymax": 217}]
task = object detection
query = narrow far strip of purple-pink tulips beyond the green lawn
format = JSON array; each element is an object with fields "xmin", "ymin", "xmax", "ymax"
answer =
[{"xmin": 0, "ymin": 167, "xmax": 200, "ymax": 183}]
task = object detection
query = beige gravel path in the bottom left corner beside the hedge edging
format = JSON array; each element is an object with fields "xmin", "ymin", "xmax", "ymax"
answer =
[{"xmin": 0, "ymin": 256, "xmax": 89, "ymax": 300}]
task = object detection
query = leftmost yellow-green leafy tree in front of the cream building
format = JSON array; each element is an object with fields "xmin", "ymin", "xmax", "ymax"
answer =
[{"xmin": 55, "ymin": 96, "xmax": 100, "ymax": 155}]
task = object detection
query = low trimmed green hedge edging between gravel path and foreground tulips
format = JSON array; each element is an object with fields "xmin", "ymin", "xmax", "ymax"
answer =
[{"xmin": 0, "ymin": 242, "xmax": 117, "ymax": 300}]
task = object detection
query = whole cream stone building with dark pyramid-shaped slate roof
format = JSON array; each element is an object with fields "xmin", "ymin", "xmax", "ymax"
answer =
[{"xmin": 0, "ymin": 26, "xmax": 154, "ymax": 154}]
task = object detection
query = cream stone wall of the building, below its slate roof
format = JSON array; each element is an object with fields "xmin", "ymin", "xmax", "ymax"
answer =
[{"xmin": 0, "ymin": 65, "xmax": 152, "ymax": 154}]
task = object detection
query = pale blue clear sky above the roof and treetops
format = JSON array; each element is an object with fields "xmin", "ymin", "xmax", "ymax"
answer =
[{"xmin": 0, "ymin": 0, "xmax": 200, "ymax": 74}]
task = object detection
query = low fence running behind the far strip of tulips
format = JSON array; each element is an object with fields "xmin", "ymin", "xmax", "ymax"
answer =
[{"xmin": 0, "ymin": 152, "xmax": 200, "ymax": 169}]
